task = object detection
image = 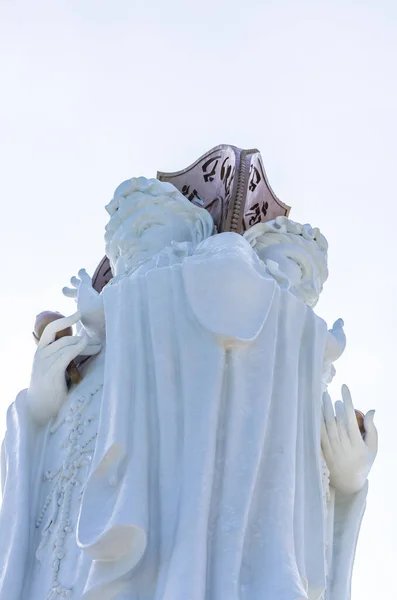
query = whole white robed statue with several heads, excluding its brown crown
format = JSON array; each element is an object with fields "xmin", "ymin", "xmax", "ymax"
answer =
[{"xmin": 0, "ymin": 178, "xmax": 376, "ymax": 600}]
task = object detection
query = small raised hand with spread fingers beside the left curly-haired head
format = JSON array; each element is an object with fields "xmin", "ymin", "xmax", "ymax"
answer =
[{"xmin": 62, "ymin": 269, "xmax": 105, "ymax": 340}]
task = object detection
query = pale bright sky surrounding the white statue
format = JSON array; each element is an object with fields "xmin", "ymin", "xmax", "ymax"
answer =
[{"xmin": 0, "ymin": 0, "xmax": 397, "ymax": 600}]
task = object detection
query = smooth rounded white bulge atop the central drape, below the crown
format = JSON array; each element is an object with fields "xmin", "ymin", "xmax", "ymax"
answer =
[{"xmin": 182, "ymin": 233, "xmax": 277, "ymax": 342}]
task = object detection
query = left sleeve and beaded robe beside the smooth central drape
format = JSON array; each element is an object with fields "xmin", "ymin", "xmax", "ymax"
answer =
[{"xmin": 0, "ymin": 354, "xmax": 105, "ymax": 600}]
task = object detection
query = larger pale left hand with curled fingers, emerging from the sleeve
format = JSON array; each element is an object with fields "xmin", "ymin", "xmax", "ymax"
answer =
[{"xmin": 27, "ymin": 312, "xmax": 101, "ymax": 424}]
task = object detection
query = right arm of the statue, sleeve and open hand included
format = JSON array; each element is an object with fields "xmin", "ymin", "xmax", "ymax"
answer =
[{"xmin": 321, "ymin": 386, "xmax": 378, "ymax": 600}]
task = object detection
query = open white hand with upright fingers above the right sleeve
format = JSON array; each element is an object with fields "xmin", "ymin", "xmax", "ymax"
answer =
[{"xmin": 321, "ymin": 385, "xmax": 378, "ymax": 494}]
